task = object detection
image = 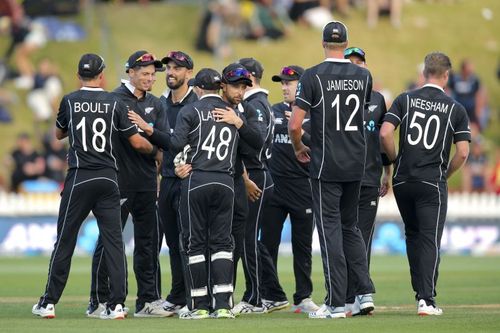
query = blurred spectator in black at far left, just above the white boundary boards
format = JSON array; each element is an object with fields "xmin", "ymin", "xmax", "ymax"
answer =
[{"xmin": 7, "ymin": 133, "xmax": 45, "ymax": 192}]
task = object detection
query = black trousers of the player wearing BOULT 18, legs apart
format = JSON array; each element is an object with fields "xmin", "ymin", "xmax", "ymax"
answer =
[{"xmin": 40, "ymin": 169, "xmax": 126, "ymax": 307}]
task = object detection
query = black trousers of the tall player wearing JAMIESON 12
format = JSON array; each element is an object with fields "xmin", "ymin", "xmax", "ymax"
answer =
[{"xmin": 311, "ymin": 179, "xmax": 375, "ymax": 307}]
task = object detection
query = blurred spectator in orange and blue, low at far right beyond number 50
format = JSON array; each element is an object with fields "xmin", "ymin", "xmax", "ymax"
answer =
[{"xmin": 462, "ymin": 135, "xmax": 488, "ymax": 192}]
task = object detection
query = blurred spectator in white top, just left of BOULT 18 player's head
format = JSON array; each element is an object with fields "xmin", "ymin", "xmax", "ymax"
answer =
[{"xmin": 27, "ymin": 58, "xmax": 62, "ymax": 138}]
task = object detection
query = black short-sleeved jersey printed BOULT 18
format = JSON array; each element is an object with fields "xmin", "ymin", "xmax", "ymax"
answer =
[{"xmin": 56, "ymin": 87, "xmax": 137, "ymax": 171}]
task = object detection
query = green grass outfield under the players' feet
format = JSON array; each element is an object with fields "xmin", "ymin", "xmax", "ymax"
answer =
[{"xmin": 0, "ymin": 256, "xmax": 500, "ymax": 333}]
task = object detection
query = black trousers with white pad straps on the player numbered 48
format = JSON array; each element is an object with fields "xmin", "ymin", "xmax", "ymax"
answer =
[{"xmin": 179, "ymin": 170, "xmax": 234, "ymax": 310}]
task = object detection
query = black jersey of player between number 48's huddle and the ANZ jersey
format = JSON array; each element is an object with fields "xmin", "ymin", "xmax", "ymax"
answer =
[{"xmin": 239, "ymin": 89, "xmax": 274, "ymax": 170}]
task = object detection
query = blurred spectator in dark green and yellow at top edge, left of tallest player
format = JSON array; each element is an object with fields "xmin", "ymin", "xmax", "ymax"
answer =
[{"xmin": 241, "ymin": 0, "xmax": 291, "ymax": 39}]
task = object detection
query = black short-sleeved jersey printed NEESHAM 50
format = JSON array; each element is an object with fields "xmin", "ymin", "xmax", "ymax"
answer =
[{"xmin": 384, "ymin": 84, "xmax": 471, "ymax": 184}]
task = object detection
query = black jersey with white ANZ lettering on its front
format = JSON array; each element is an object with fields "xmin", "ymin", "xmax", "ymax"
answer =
[{"xmin": 269, "ymin": 102, "xmax": 309, "ymax": 178}]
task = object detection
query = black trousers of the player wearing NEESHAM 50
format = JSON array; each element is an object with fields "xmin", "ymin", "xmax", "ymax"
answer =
[{"xmin": 393, "ymin": 181, "xmax": 448, "ymax": 301}]
